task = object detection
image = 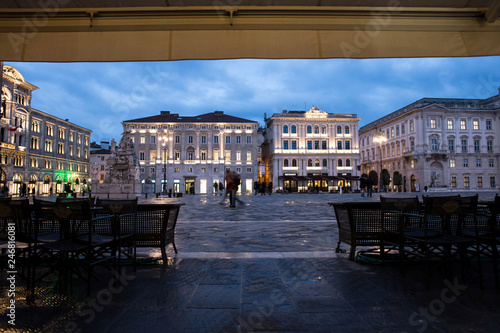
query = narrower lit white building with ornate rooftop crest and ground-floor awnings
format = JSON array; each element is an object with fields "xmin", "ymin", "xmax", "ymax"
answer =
[{"xmin": 263, "ymin": 106, "xmax": 360, "ymax": 192}]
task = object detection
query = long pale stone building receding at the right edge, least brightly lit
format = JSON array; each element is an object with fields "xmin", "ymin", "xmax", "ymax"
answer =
[{"xmin": 359, "ymin": 90, "xmax": 500, "ymax": 192}]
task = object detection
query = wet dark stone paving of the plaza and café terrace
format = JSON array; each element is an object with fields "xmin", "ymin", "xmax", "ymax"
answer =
[{"xmin": 0, "ymin": 192, "xmax": 500, "ymax": 333}]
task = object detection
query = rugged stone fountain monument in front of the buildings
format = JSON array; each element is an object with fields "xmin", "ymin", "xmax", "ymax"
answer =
[{"xmin": 93, "ymin": 133, "xmax": 142, "ymax": 198}]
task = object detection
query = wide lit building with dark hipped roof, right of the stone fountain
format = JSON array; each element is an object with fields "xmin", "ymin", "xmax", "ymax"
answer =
[{"xmin": 122, "ymin": 111, "xmax": 258, "ymax": 194}]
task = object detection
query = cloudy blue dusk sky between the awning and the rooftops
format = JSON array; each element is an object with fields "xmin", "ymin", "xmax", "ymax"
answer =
[{"xmin": 6, "ymin": 56, "xmax": 500, "ymax": 142}]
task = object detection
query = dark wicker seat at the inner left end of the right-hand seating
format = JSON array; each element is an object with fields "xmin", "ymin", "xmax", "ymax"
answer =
[{"xmin": 328, "ymin": 202, "xmax": 392, "ymax": 260}]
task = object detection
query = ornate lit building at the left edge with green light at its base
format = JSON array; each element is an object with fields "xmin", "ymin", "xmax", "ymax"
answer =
[{"xmin": 0, "ymin": 65, "xmax": 92, "ymax": 195}]
